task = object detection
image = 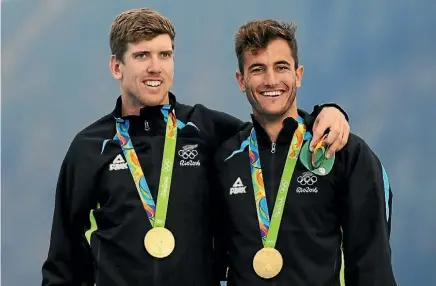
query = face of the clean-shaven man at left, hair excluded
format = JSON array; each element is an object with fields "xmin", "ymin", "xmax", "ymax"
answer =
[{"xmin": 111, "ymin": 34, "xmax": 174, "ymax": 106}]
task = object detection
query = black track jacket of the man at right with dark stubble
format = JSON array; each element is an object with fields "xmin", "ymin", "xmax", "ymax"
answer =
[{"xmin": 215, "ymin": 111, "xmax": 396, "ymax": 286}]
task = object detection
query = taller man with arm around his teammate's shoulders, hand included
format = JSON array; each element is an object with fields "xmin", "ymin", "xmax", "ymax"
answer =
[{"xmin": 42, "ymin": 8, "xmax": 348, "ymax": 286}]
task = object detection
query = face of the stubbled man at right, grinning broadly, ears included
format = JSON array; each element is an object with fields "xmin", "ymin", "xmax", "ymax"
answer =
[{"xmin": 236, "ymin": 37, "xmax": 303, "ymax": 120}]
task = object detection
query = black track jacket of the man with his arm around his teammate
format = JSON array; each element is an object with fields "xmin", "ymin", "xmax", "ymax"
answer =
[{"xmin": 42, "ymin": 94, "xmax": 346, "ymax": 286}]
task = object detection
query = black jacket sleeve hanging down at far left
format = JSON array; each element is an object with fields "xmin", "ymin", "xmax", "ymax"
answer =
[{"xmin": 41, "ymin": 138, "xmax": 94, "ymax": 286}]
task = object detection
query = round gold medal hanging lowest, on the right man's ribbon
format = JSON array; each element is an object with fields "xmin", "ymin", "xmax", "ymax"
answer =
[{"xmin": 253, "ymin": 247, "xmax": 283, "ymax": 279}]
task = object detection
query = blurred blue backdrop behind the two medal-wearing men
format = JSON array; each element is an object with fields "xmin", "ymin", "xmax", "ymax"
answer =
[{"xmin": 1, "ymin": 0, "xmax": 436, "ymax": 286}]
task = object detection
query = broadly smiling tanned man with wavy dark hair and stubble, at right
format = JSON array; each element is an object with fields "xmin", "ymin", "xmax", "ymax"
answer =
[{"xmin": 215, "ymin": 20, "xmax": 396, "ymax": 286}]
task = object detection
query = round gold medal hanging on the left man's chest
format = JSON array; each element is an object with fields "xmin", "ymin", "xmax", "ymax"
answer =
[{"xmin": 144, "ymin": 227, "xmax": 175, "ymax": 258}]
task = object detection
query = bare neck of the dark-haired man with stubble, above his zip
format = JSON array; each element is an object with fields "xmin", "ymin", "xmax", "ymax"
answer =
[{"xmin": 253, "ymin": 105, "xmax": 298, "ymax": 143}]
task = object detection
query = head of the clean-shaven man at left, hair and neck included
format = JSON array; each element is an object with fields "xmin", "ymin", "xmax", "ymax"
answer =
[{"xmin": 109, "ymin": 8, "xmax": 176, "ymax": 115}]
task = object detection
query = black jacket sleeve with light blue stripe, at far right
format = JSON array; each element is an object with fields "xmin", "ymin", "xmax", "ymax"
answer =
[{"xmin": 341, "ymin": 137, "xmax": 396, "ymax": 286}]
